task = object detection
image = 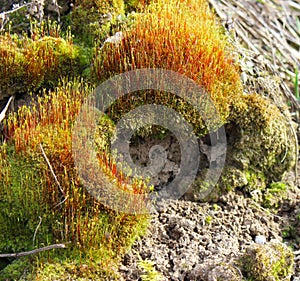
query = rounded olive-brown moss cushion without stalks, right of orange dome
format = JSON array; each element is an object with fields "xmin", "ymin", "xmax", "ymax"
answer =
[{"xmin": 231, "ymin": 94, "xmax": 295, "ymax": 182}]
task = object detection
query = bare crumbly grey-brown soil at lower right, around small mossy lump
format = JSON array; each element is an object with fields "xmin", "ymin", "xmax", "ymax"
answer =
[{"xmin": 120, "ymin": 179, "xmax": 300, "ymax": 281}]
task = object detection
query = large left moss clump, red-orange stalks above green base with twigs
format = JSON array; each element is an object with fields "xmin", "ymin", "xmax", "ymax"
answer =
[{"xmin": 0, "ymin": 81, "xmax": 148, "ymax": 280}]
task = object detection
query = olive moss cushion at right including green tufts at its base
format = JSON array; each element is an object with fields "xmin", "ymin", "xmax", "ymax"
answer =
[{"xmin": 219, "ymin": 94, "xmax": 296, "ymax": 197}]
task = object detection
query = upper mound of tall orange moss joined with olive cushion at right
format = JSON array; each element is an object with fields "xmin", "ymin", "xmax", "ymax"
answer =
[{"xmin": 94, "ymin": 0, "xmax": 296, "ymax": 200}]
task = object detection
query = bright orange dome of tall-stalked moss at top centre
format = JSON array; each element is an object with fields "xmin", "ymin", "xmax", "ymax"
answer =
[{"xmin": 94, "ymin": 0, "xmax": 242, "ymax": 135}]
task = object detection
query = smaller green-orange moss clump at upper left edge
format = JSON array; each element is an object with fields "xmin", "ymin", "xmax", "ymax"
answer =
[{"xmin": 0, "ymin": 27, "xmax": 88, "ymax": 99}]
